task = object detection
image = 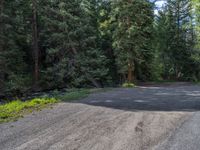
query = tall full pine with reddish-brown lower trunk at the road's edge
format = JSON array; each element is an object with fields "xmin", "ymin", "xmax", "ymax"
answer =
[{"xmin": 113, "ymin": 0, "xmax": 153, "ymax": 82}]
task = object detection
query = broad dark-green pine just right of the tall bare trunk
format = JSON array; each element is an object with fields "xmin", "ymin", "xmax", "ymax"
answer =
[{"xmin": 42, "ymin": 0, "xmax": 107, "ymax": 87}]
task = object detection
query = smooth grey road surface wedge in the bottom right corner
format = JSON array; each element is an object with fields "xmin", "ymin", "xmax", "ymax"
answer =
[{"xmin": 156, "ymin": 112, "xmax": 200, "ymax": 150}]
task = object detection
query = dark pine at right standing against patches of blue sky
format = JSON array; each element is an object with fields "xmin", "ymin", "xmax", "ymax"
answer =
[{"xmin": 157, "ymin": 0, "xmax": 195, "ymax": 80}]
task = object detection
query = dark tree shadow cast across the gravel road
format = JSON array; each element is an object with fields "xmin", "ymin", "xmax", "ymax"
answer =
[{"xmin": 75, "ymin": 85, "xmax": 200, "ymax": 112}]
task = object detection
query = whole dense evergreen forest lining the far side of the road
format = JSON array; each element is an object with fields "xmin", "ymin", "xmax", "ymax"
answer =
[{"xmin": 0, "ymin": 0, "xmax": 200, "ymax": 93}]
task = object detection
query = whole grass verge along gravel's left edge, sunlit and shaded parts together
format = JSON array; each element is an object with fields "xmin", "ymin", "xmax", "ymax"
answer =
[{"xmin": 0, "ymin": 89, "xmax": 111, "ymax": 123}]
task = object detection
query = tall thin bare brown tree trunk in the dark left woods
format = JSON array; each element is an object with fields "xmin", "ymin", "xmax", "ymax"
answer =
[{"xmin": 32, "ymin": 0, "xmax": 39, "ymax": 85}]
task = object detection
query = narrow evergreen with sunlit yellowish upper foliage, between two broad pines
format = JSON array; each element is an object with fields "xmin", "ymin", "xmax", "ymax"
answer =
[{"xmin": 98, "ymin": 0, "xmax": 119, "ymax": 84}]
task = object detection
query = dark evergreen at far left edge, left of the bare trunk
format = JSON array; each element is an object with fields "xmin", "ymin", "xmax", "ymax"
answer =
[{"xmin": 0, "ymin": 1, "xmax": 29, "ymax": 90}]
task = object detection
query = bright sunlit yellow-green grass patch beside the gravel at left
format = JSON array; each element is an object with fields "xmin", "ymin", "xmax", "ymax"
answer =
[{"xmin": 0, "ymin": 98, "xmax": 57, "ymax": 123}]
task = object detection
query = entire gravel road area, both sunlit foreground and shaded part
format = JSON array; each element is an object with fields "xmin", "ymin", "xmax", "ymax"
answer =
[{"xmin": 0, "ymin": 83, "xmax": 200, "ymax": 150}]
